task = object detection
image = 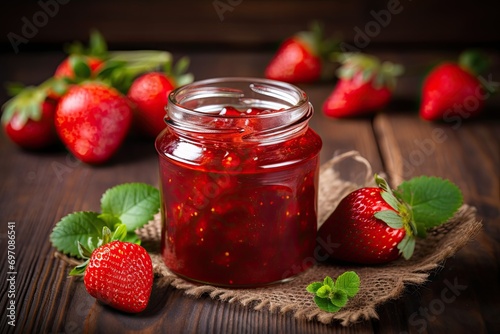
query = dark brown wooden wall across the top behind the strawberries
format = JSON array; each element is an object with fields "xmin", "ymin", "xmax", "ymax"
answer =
[{"xmin": 1, "ymin": 0, "xmax": 498, "ymax": 52}]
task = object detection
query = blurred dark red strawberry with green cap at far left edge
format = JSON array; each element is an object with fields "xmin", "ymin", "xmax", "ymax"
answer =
[{"xmin": 2, "ymin": 86, "xmax": 57, "ymax": 150}]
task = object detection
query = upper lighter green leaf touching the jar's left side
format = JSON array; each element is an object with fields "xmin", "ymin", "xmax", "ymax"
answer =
[{"xmin": 101, "ymin": 183, "xmax": 160, "ymax": 232}]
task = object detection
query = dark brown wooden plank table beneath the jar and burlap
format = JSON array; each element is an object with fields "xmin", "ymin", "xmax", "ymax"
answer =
[{"xmin": 0, "ymin": 50, "xmax": 500, "ymax": 333}]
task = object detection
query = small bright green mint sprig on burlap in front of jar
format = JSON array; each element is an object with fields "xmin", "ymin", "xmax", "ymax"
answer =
[{"xmin": 306, "ymin": 271, "xmax": 361, "ymax": 313}]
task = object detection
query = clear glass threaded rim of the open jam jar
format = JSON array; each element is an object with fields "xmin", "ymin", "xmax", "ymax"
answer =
[{"xmin": 166, "ymin": 77, "xmax": 313, "ymax": 141}]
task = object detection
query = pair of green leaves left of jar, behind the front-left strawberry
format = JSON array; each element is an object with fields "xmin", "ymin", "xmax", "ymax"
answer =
[{"xmin": 50, "ymin": 183, "xmax": 160, "ymax": 258}]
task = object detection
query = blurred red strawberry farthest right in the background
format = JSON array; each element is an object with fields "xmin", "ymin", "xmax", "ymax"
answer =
[{"xmin": 419, "ymin": 50, "xmax": 488, "ymax": 121}]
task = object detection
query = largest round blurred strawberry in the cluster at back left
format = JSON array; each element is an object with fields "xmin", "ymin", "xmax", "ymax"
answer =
[{"xmin": 55, "ymin": 82, "xmax": 132, "ymax": 163}]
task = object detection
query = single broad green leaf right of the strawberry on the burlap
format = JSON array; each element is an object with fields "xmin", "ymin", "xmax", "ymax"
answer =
[{"xmin": 397, "ymin": 176, "xmax": 463, "ymax": 230}]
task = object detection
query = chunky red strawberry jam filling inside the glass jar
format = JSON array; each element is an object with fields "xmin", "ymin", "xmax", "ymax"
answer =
[{"xmin": 157, "ymin": 107, "xmax": 321, "ymax": 286}]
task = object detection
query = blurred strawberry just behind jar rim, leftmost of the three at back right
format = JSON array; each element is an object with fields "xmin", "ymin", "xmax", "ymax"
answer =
[{"xmin": 264, "ymin": 22, "xmax": 338, "ymax": 84}]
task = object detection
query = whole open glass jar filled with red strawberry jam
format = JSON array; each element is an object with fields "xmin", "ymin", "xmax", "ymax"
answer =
[{"xmin": 155, "ymin": 78, "xmax": 321, "ymax": 287}]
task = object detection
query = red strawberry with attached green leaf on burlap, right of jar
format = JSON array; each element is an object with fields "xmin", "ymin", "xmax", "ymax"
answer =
[{"xmin": 318, "ymin": 176, "xmax": 463, "ymax": 264}]
